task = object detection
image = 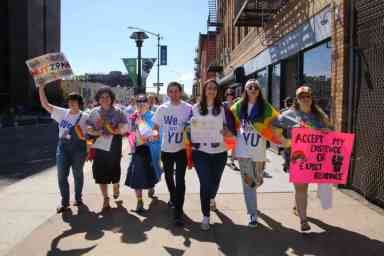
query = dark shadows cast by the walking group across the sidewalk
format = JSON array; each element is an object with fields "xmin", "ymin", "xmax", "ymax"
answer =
[{"xmin": 43, "ymin": 199, "xmax": 384, "ymax": 256}]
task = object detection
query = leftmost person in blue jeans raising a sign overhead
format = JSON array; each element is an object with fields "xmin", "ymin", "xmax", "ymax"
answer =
[{"xmin": 39, "ymin": 84, "xmax": 88, "ymax": 213}]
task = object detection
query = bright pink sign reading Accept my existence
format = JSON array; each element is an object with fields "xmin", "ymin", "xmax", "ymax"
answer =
[{"xmin": 289, "ymin": 128, "xmax": 355, "ymax": 184}]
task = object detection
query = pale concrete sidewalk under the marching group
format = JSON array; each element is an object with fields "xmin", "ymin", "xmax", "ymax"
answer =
[{"xmin": 0, "ymin": 145, "xmax": 384, "ymax": 255}]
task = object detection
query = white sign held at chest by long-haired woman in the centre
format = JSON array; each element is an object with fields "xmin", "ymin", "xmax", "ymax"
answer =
[{"xmin": 191, "ymin": 116, "xmax": 224, "ymax": 143}]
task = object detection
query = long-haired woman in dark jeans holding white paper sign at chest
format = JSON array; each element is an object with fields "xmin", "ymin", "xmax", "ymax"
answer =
[{"xmin": 191, "ymin": 80, "xmax": 230, "ymax": 230}]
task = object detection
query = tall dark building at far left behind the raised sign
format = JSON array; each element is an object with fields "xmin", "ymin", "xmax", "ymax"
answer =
[{"xmin": 0, "ymin": 0, "xmax": 61, "ymax": 112}]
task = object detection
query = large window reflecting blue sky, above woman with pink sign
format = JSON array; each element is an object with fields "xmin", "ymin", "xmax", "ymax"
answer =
[{"xmin": 303, "ymin": 43, "xmax": 331, "ymax": 115}]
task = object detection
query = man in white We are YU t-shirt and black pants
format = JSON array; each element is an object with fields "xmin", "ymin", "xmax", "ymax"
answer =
[{"xmin": 153, "ymin": 82, "xmax": 192, "ymax": 226}]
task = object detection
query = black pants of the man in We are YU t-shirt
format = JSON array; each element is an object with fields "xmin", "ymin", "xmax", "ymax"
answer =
[{"xmin": 161, "ymin": 149, "xmax": 187, "ymax": 218}]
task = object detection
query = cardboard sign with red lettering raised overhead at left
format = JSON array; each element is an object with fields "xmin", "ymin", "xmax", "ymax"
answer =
[{"xmin": 25, "ymin": 52, "xmax": 73, "ymax": 87}]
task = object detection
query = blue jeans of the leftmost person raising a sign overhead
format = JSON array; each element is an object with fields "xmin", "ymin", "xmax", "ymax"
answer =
[{"xmin": 56, "ymin": 139, "xmax": 87, "ymax": 207}]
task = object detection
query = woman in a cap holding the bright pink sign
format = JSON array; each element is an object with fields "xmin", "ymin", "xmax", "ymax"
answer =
[{"xmin": 273, "ymin": 86, "xmax": 330, "ymax": 231}]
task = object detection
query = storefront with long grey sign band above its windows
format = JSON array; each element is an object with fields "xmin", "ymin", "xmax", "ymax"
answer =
[{"xmin": 244, "ymin": 7, "xmax": 331, "ymax": 114}]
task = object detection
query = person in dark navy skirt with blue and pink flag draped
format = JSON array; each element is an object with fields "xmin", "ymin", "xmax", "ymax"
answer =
[{"xmin": 125, "ymin": 95, "xmax": 162, "ymax": 212}]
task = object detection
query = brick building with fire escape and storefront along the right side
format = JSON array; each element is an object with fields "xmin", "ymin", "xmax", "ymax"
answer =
[{"xmin": 208, "ymin": 0, "xmax": 384, "ymax": 205}]
